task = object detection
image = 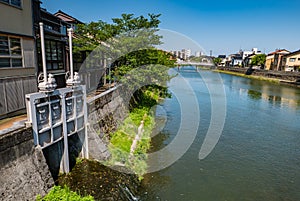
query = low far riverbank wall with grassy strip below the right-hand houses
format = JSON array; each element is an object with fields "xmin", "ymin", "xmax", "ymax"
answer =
[{"xmin": 214, "ymin": 67, "xmax": 300, "ymax": 87}]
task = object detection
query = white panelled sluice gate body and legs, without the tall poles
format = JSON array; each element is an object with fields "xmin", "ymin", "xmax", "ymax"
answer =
[{"xmin": 26, "ymin": 85, "xmax": 88, "ymax": 172}]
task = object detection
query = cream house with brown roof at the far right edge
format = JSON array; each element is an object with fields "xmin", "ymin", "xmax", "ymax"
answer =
[{"xmin": 282, "ymin": 50, "xmax": 300, "ymax": 72}]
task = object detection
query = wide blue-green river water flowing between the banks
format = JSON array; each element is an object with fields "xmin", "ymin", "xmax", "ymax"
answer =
[{"xmin": 139, "ymin": 67, "xmax": 300, "ymax": 201}]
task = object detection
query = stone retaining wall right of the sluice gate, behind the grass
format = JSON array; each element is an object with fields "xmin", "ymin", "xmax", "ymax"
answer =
[{"xmin": 88, "ymin": 86, "xmax": 128, "ymax": 161}]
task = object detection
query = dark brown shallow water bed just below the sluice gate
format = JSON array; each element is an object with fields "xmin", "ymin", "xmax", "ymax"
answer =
[{"xmin": 58, "ymin": 159, "xmax": 140, "ymax": 200}]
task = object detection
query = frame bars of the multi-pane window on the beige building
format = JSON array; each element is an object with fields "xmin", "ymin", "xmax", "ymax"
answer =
[{"xmin": 0, "ymin": 34, "xmax": 24, "ymax": 69}]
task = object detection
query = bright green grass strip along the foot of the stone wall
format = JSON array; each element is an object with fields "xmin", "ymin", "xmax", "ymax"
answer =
[{"xmin": 108, "ymin": 88, "xmax": 167, "ymax": 179}]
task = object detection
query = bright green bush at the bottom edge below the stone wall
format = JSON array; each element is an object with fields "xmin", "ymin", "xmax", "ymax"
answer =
[{"xmin": 36, "ymin": 186, "xmax": 94, "ymax": 201}]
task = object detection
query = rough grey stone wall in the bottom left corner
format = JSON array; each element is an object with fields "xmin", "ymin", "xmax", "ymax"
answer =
[{"xmin": 0, "ymin": 128, "xmax": 54, "ymax": 201}]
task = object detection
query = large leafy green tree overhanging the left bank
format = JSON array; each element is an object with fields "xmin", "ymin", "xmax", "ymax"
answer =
[{"xmin": 74, "ymin": 14, "xmax": 175, "ymax": 98}]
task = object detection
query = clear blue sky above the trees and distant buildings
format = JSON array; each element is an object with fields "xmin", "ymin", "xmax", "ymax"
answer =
[{"xmin": 42, "ymin": 0, "xmax": 300, "ymax": 55}]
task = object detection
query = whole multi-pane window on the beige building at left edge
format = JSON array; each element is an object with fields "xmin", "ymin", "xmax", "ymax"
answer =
[{"xmin": 0, "ymin": 35, "xmax": 23, "ymax": 68}]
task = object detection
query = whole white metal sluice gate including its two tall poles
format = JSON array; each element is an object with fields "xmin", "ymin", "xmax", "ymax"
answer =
[{"xmin": 25, "ymin": 22, "xmax": 89, "ymax": 173}]
